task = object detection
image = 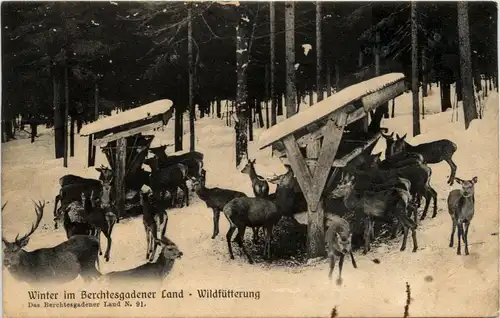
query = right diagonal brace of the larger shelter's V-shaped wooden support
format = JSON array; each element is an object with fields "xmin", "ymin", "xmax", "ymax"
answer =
[{"xmin": 309, "ymin": 113, "xmax": 347, "ymax": 211}]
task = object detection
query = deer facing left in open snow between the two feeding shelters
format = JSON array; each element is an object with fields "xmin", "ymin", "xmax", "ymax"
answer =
[{"xmin": 191, "ymin": 171, "xmax": 248, "ymax": 243}]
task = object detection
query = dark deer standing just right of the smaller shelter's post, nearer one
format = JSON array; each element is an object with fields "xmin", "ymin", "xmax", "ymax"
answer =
[{"xmin": 144, "ymin": 157, "xmax": 189, "ymax": 207}]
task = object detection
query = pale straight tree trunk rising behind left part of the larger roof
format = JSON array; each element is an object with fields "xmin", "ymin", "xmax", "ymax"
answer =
[{"xmin": 285, "ymin": 1, "xmax": 297, "ymax": 118}]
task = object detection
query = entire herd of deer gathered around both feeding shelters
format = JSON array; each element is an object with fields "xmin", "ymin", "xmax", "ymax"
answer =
[{"xmin": 2, "ymin": 133, "xmax": 478, "ymax": 284}]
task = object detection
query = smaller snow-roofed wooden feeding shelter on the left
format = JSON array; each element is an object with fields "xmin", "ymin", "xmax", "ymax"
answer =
[{"xmin": 80, "ymin": 99, "xmax": 174, "ymax": 219}]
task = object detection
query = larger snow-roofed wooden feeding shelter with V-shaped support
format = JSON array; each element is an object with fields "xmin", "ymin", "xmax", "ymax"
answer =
[{"xmin": 259, "ymin": 73, "xmax": 406, "ymax": 257}]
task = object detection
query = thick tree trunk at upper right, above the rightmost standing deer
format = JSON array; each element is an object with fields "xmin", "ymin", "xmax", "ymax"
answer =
[{"xmin": 457, "ymin": 1, "xmax": 477, "ymax": 129}]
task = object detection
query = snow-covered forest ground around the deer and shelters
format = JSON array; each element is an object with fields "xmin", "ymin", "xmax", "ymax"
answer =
[{"xmin": 2, "ymin": 83, "xmax": 499, "ymax": 317}]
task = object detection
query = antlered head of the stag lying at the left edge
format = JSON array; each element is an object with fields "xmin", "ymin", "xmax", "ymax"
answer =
[{"xmin": 2, "ymin": 201, "xmax": 45, "ymax": 268}]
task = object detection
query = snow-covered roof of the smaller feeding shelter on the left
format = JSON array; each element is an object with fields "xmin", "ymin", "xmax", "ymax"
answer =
[{"xmin": 80, "ymin": 99, "xmax": 173, "ymax": 136}]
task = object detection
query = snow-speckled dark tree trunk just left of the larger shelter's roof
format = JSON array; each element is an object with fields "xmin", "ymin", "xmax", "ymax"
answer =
[{"xmin": 235, "ymin": 12, "xmax": 249, "ymax": 166}]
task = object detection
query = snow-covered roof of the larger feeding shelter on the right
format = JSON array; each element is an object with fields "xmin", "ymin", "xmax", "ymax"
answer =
[{"xmin": 259, "ymin": 73, "xmax": 405, "ymax": 149}]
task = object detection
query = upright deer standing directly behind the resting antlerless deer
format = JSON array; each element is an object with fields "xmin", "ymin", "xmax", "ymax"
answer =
[{"xmin": 140, "ymin": 191, "xmax": 168, "ymax": 262}]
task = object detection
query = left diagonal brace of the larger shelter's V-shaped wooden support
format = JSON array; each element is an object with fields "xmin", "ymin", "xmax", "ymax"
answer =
[{"xmin": 283, "ymin": 135, "xmax": 313, "ymax": 205}]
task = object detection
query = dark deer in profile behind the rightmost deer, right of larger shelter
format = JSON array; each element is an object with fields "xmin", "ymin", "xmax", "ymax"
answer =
[{"xmin": 393, "ymin": 134, "xmax": 457, "ymax": 186}]
